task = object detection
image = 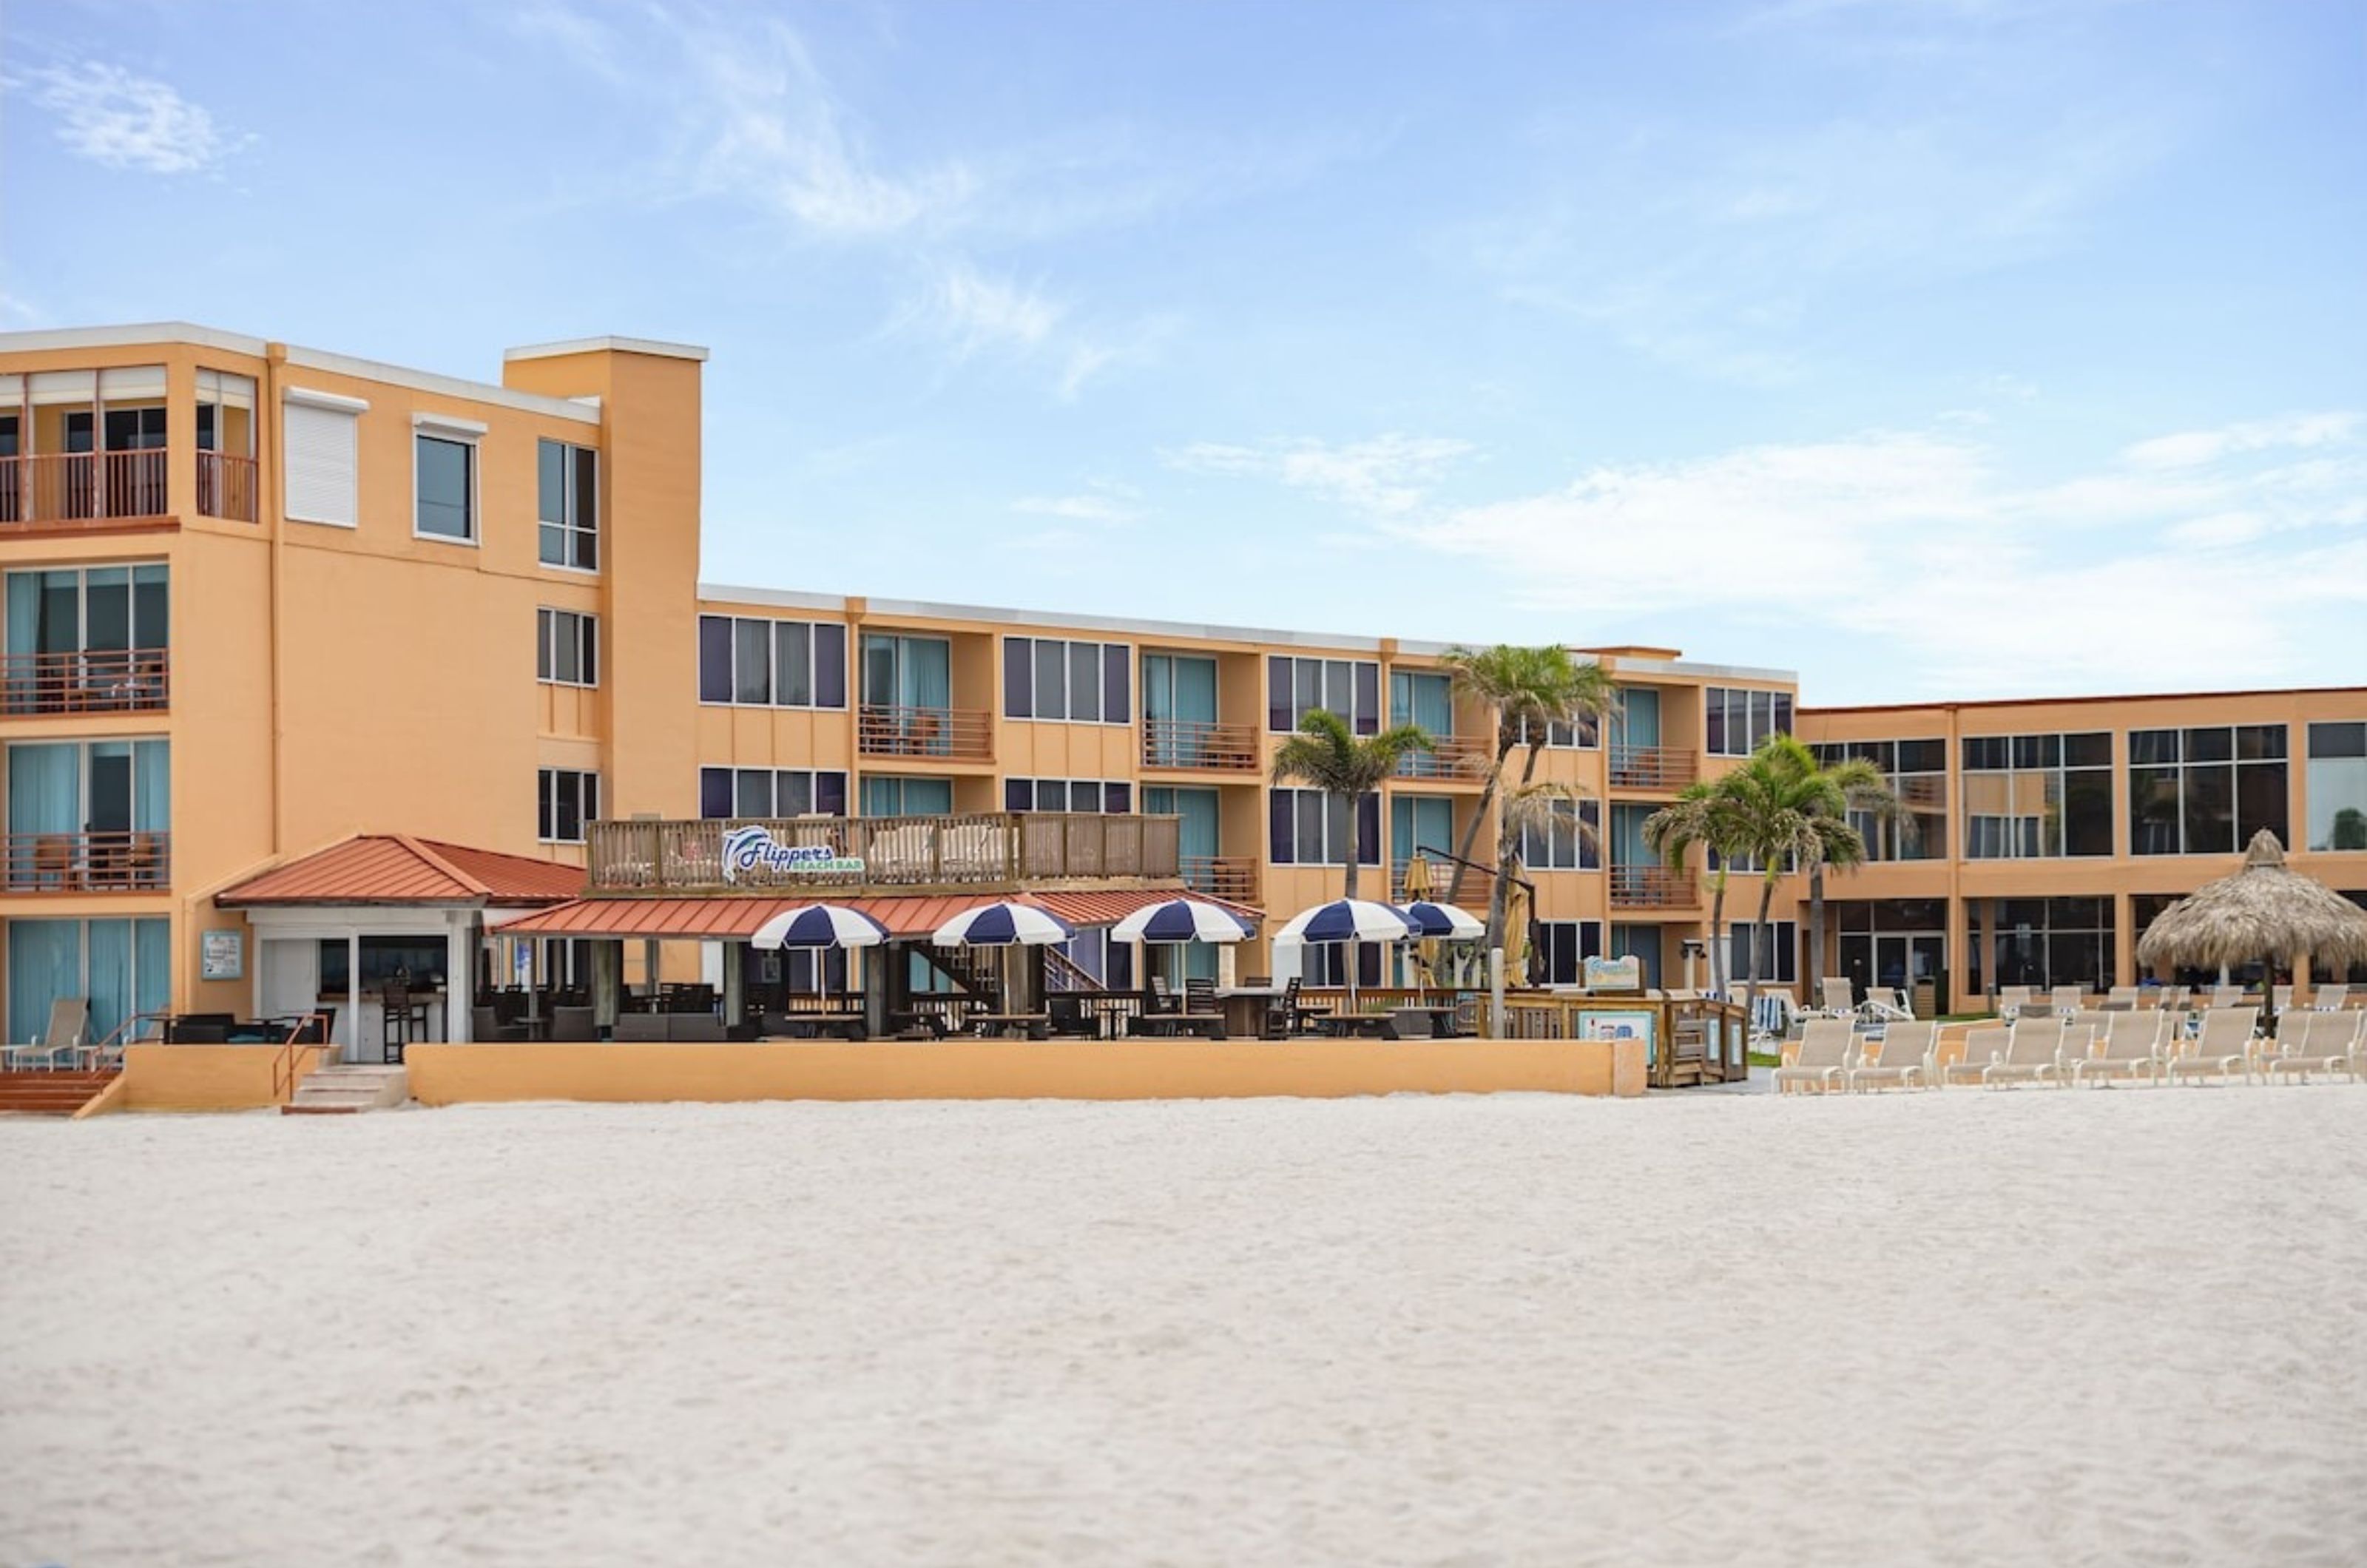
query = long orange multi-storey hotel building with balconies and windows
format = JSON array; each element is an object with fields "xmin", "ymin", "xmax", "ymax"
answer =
[{"xmin": 0, "ymin": 325, "xmax": 2367, "ymax": 1040}]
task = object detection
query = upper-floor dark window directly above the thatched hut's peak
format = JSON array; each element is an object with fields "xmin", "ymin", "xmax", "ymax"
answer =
[{"xmin": 2128, "ymin": 725, "xmax": 2289, "ymax": 855}]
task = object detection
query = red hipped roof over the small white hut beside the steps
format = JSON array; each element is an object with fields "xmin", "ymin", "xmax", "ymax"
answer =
[{"xmin": 213, "ymin": 834, "xmax": 584, "ymax": 910}]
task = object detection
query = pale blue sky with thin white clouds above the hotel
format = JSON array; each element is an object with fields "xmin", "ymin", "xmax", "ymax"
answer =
[{"xmin": 0, "ymin": 0, "xmax": 2367, "ymax": 703}]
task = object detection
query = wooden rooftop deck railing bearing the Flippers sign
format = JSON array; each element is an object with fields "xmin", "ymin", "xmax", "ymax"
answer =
[{"xmin": 584, "ymin": 812, "xmax": 1181, "ymax": 893}]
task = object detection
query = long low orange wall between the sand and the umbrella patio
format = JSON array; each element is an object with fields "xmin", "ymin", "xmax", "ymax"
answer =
[{"xmin": 405, "ymin": 1040, "xmax": 1645, "ymax": 1106}]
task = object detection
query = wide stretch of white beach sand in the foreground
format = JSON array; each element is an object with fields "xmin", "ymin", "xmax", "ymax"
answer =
[{"xmin": 0, "ymin": 1085, "xmax": 2367, "ymax": 1568}]
